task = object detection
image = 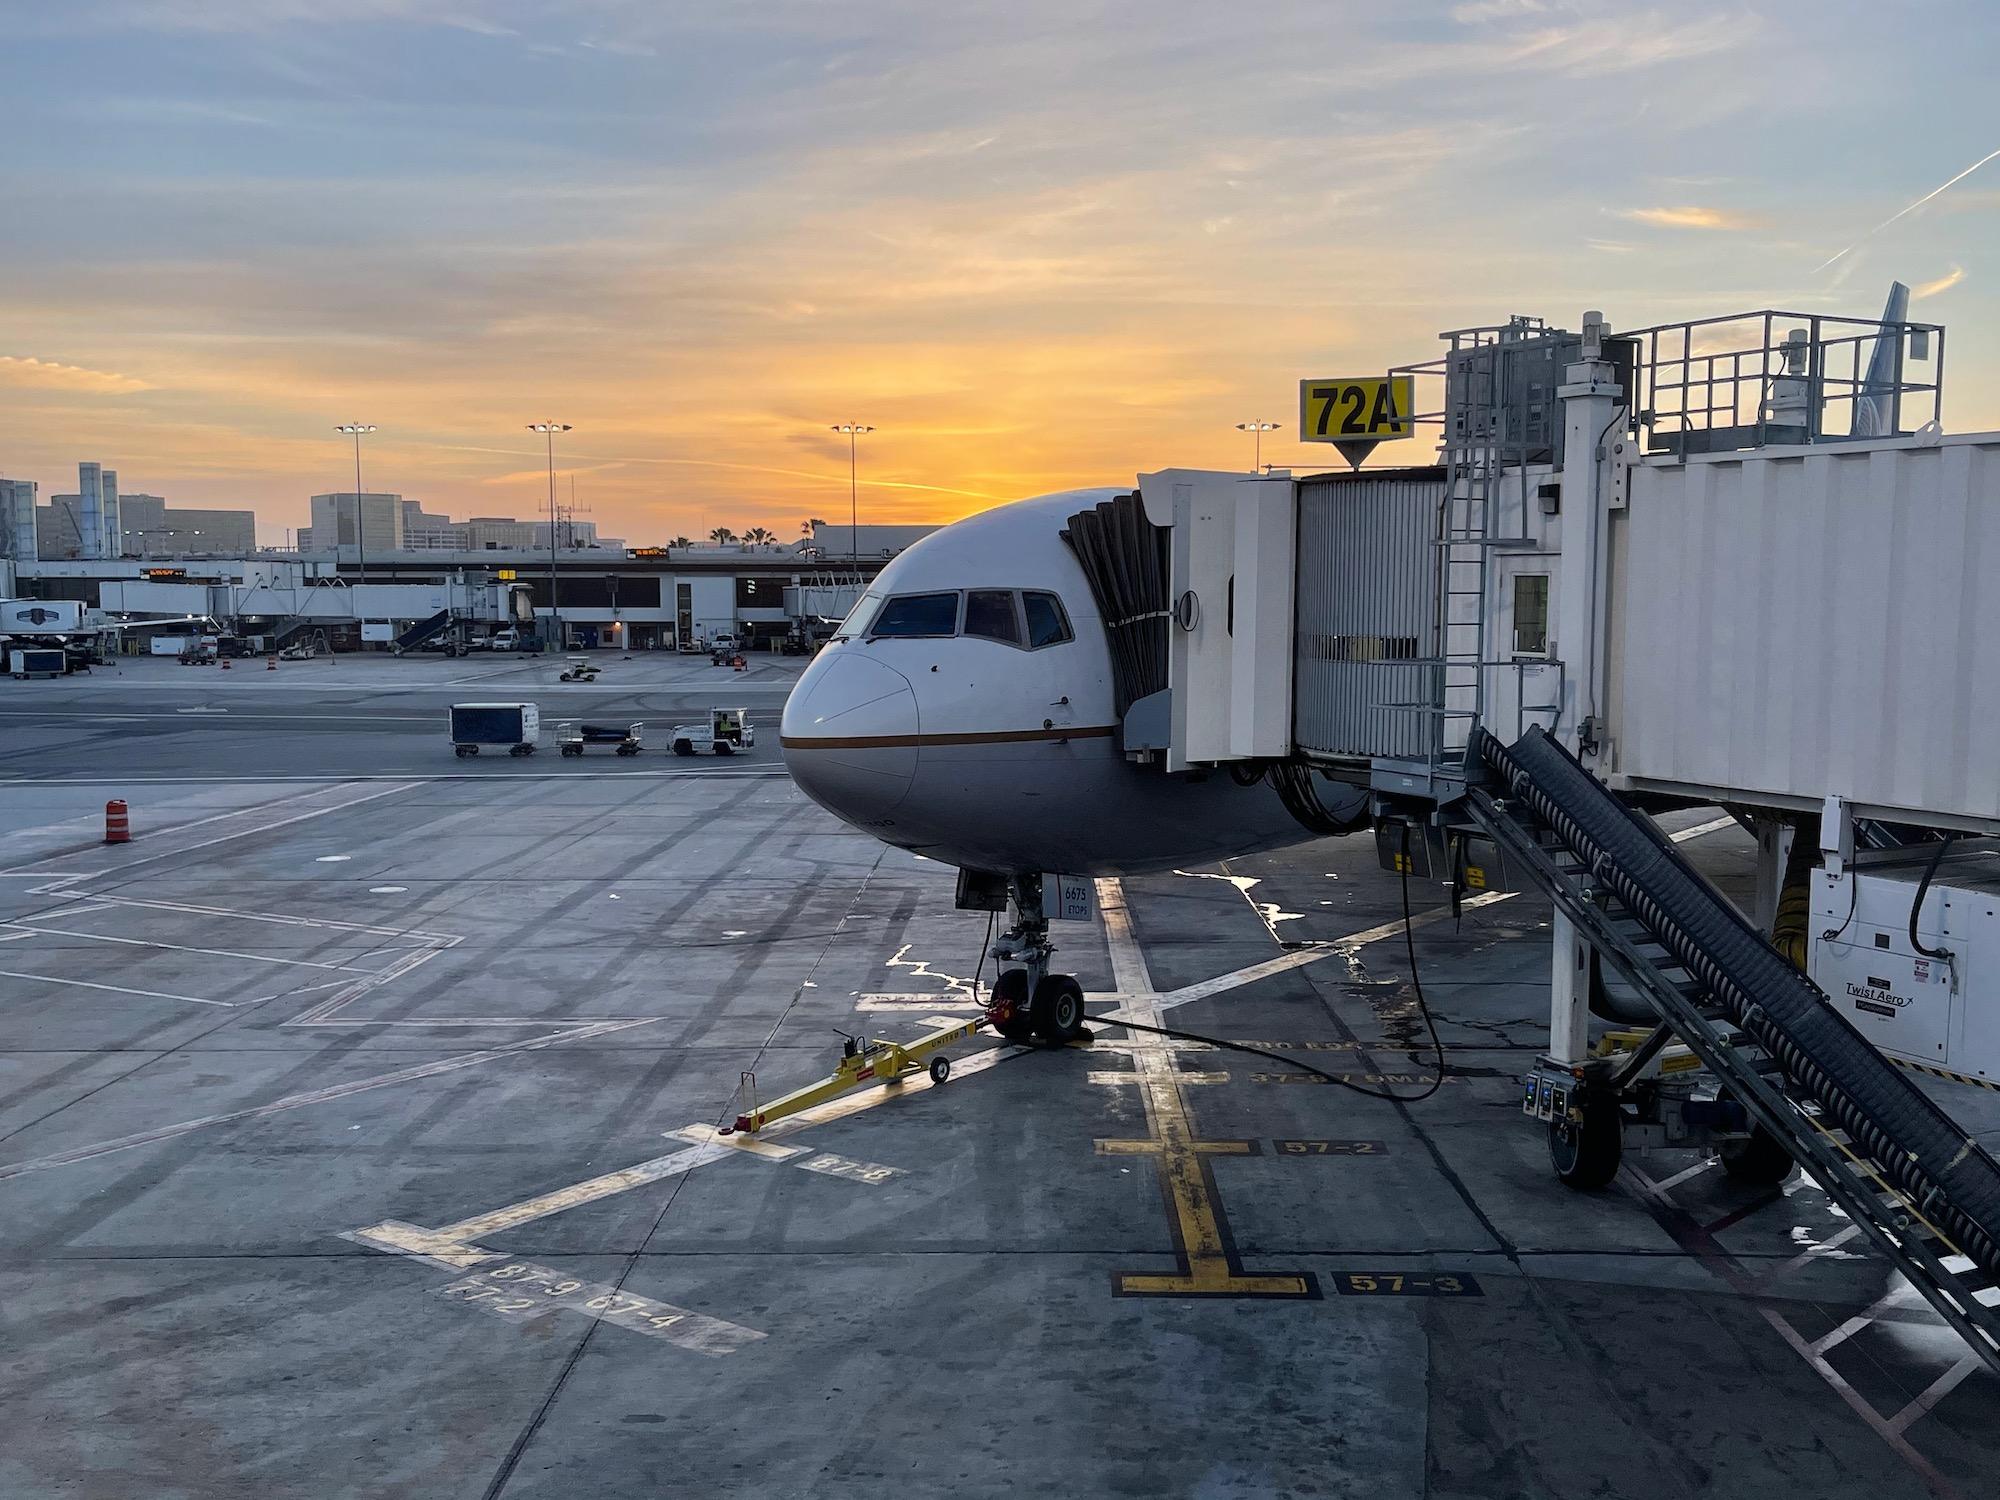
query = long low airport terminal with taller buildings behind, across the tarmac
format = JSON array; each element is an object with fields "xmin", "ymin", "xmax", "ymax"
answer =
[{"xmin": 0, "ymin": 464, "xmax": 936, "ymax": 650}]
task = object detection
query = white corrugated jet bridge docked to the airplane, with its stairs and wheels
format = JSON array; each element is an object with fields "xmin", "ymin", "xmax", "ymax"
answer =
[{"xmin": 1086, "ymin": 294, "xmax": 2000, "ymax": 1370}]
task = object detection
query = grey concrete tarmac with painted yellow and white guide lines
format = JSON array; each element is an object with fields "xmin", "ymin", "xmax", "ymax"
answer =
[{"xmin": 0, "ymin": 652, "xmax": 2000, "ymax": 1500}]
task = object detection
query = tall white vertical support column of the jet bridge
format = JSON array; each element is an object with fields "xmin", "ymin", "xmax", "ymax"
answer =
[{"xmin": 1548, "ymin": 312, "xmax": 1628, "ymax": 1062}]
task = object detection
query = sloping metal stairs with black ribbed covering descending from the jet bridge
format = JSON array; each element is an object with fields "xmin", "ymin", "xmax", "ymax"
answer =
[{"xmin": 1466, "ymin": 730, "xmax": 2000, "ymax": 1374}]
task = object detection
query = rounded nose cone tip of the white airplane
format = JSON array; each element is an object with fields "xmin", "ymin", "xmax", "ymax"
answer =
[{"xmin": 778, "ymin": 642, "xmax": 918, "ymax": 826}]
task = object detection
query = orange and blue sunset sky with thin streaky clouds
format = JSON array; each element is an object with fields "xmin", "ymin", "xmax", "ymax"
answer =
[{"xmin": 0, "ymin": 0, "xmax": 2000, "ymax": 542}]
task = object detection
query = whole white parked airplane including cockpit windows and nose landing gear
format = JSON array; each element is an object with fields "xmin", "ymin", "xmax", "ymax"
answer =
[{"xmin": 778, "ymin": 488, "xmax": 1368, "ymax": 1042}]
